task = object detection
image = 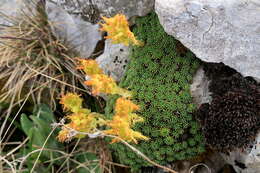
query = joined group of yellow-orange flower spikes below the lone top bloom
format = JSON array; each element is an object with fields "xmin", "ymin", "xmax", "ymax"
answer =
[{"xmin": 58, "ymin": 59, "xmax": 148, "ymax": 143}]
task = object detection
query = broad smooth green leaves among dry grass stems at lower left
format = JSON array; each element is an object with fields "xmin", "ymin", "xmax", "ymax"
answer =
[{"xmin": 20, "ymin": 104, "xmax": 64, "ymax": 172}]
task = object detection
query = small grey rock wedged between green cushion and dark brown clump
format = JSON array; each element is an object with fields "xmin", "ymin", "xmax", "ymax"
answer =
[{"xmin": 190, "ymin": 67, "xmax": 212, "ymax": 107}]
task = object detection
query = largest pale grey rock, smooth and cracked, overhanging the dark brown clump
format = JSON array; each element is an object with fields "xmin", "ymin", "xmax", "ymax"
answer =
[{"xmin": 155, "ymin": 0, "xmax": 260, "ymax": 78}]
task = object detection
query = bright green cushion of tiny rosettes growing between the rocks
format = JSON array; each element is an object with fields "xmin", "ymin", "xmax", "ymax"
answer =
[{"xmin": 106, "ymin": 13, "xmax": 204, "ymax": 170}]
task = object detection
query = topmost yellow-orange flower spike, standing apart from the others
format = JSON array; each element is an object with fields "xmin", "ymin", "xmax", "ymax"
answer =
[{"xmin": 100, "ymin": 14, "xmax": 143, "ymax": 46}]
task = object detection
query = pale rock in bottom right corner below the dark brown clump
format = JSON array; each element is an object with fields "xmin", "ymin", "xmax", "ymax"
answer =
[{"xmin": 222, "ymin": 132, "xmax": 260, "ymax": 173}]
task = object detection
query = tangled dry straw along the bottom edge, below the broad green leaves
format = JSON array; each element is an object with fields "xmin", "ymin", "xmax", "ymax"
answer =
[{"xmin": 0, "ymin": 137, "xmax": 112, "ymax": 173}]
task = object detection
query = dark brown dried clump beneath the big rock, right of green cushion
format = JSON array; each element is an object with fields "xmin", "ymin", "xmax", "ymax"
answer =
[{"xmin": 198, "ymin": 65, "xmax": 260, "ymax": 151}]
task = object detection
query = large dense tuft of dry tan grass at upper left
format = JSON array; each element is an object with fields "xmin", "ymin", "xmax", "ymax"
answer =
[{"xmin": 0, "ymin": 3, "xmax": 84, "ymax": 108}]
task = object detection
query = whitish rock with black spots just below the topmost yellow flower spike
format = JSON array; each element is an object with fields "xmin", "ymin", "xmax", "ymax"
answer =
[{"xmin": 96, "ymin": 40, "xmax": 130, "ymax": 81}]
